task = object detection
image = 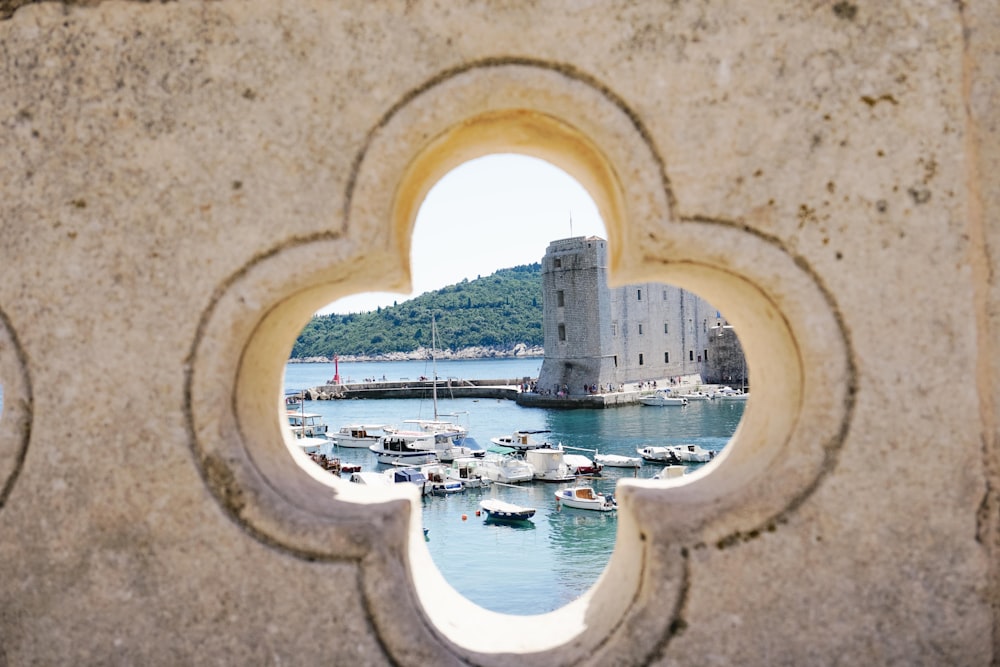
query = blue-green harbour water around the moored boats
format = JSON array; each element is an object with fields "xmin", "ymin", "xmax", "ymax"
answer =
[{"xmin": 285, "ymin": 358, "xmax": 745, "ymax": 614}]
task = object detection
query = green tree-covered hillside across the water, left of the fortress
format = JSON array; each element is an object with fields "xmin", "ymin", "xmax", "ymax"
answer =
[{"xmin": 292, "ymin": 263, "xmax": 542, "ymax": 359}]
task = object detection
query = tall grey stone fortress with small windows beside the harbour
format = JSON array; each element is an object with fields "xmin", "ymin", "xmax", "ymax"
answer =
[{"xmin": 538, "ymin": 236, "xmax": 746, "ymax": 396}]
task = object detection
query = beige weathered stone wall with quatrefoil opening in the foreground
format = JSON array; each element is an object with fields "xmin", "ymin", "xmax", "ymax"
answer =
[{"xmin": 0, "ymin": 0, "xmax": 1000, "ymax": 666}]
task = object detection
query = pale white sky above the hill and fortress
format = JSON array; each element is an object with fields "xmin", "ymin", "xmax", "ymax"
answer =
[{"xmin": 319, "ymin": 155, "xmax": 608, "ymax": 314}]
